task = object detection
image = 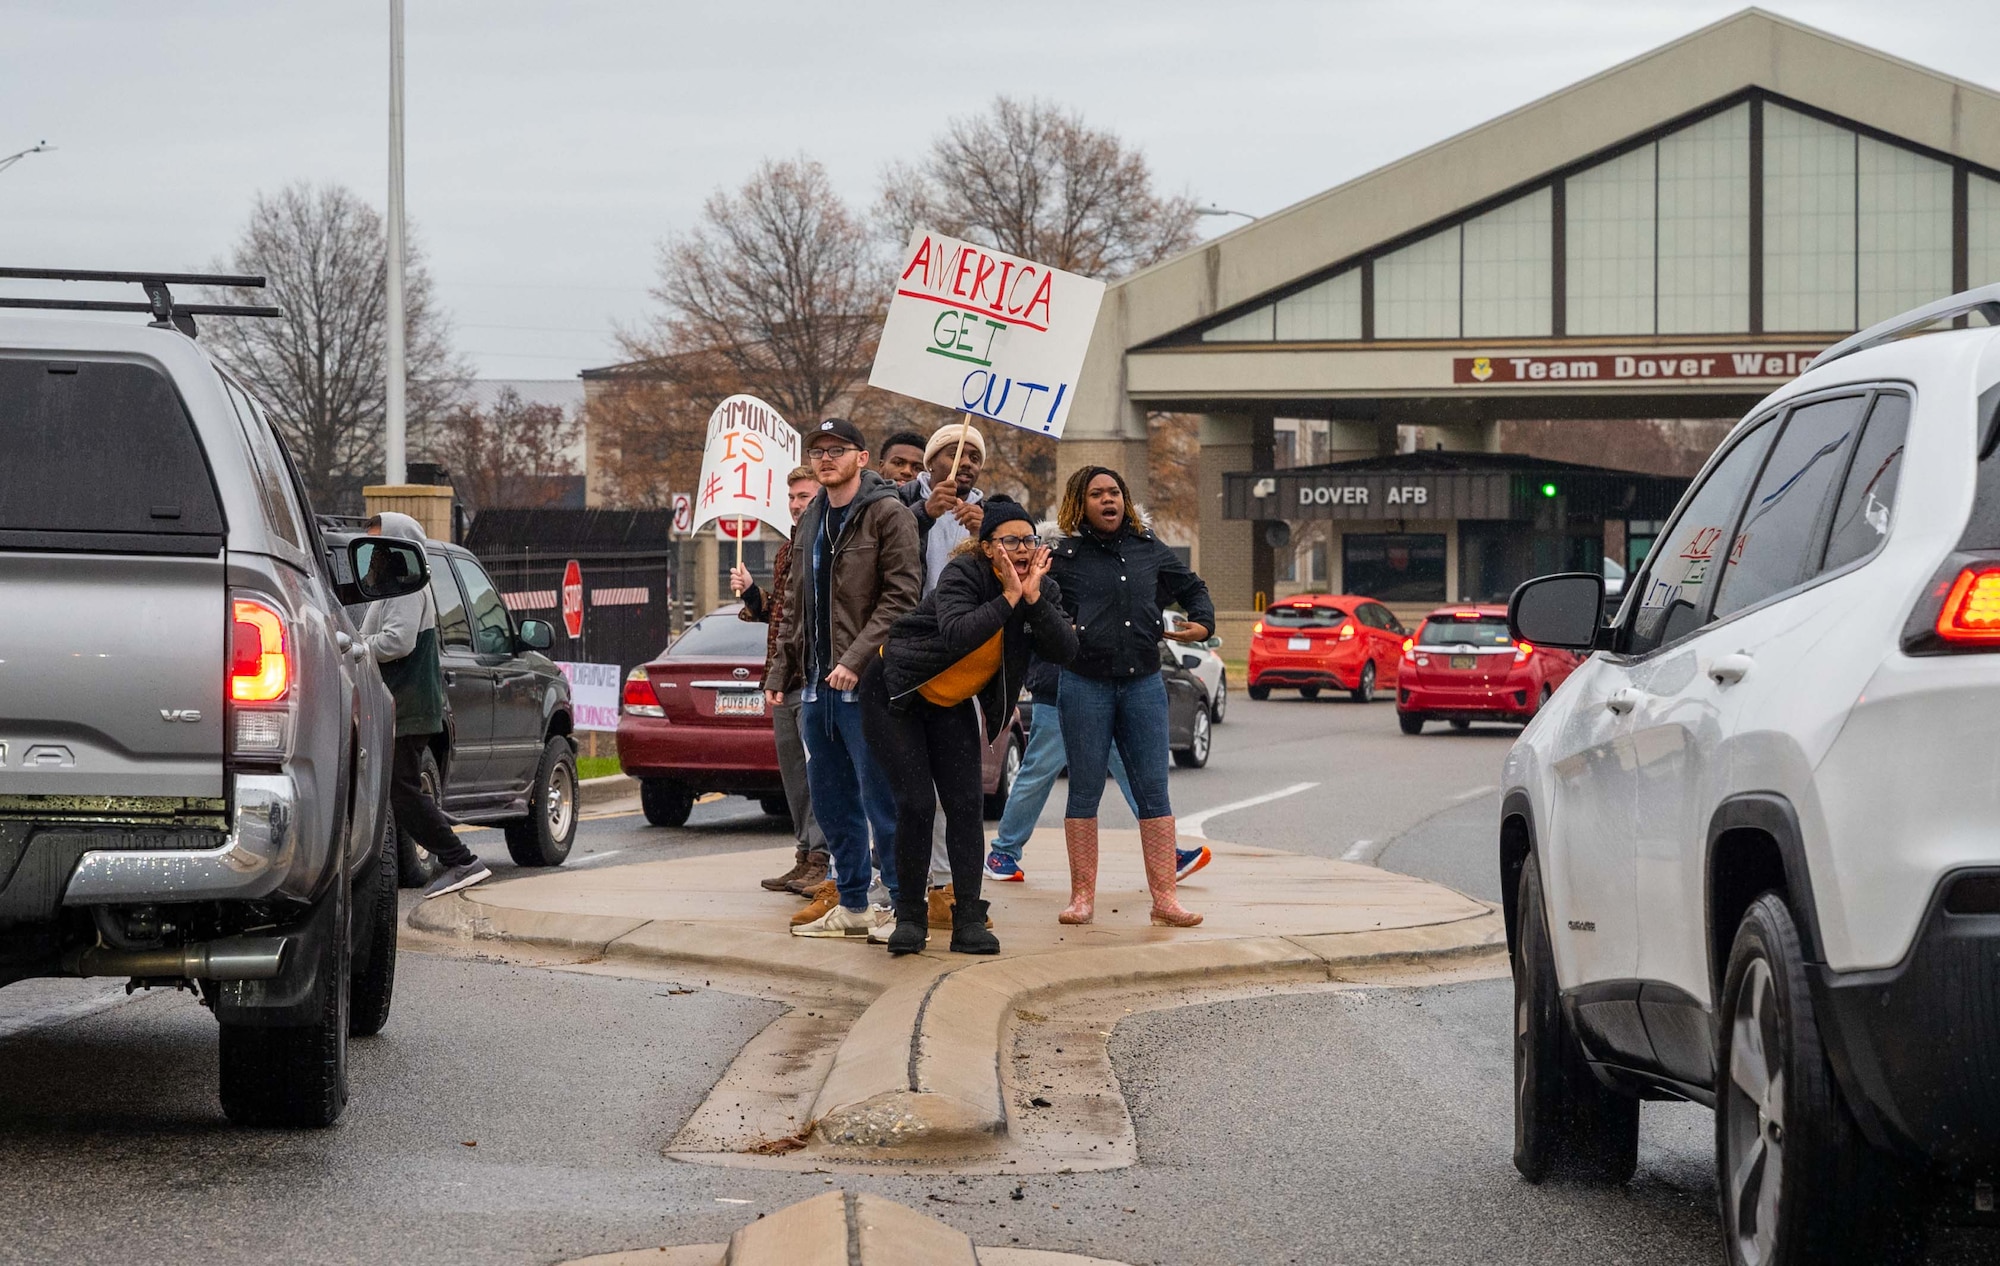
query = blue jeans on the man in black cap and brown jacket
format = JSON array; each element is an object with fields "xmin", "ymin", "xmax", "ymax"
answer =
[{"xmin": 798, "ymin": 686, "xmax": 896, "ymax": 910}]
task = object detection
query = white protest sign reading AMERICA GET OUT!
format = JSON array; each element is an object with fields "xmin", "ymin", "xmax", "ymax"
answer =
[{"xmin": 868, "ymin": 228, "xmax": 1104, "ymax": 436}]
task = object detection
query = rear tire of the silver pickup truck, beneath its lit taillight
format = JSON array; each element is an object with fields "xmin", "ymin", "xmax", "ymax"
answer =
[{"xmin": 218, "ymin": 878, "xmax": 350, "ymax": 1130}]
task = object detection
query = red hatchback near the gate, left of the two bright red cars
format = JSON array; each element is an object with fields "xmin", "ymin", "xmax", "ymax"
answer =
[{"xmin": 1250, "ymin": 594, "xmax": 1410, "ymax": 704}]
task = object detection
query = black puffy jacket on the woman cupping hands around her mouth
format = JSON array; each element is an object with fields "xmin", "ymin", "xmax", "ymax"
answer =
[{"xmin": 882, "ymin": 554, "xmax": 1076, "ymax": 742}]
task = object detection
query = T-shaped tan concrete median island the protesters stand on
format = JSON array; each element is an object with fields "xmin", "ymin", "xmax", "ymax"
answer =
[{"xmin": 410, "ymin": 830, "xmax": 1504, "ymax": 1172}]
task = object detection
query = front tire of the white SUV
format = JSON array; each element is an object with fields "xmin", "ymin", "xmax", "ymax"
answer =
[{"xmin": 1514, "ymin": 856, "xmax": 1638, "ymax": 1184}]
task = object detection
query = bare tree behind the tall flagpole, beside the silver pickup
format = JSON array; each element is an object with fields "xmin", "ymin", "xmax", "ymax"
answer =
[{"xmin": 204, "ymin": 182, "xmax": 468, "ymax": 508}]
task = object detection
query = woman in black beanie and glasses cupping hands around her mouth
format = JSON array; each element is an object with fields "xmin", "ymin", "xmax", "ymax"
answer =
[{"xmin": 860, "ymin": 496, "xmax": 1076, "ymax": 954}]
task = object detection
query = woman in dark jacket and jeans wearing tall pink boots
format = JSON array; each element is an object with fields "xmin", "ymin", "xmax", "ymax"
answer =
[{"xmin": 1050, "ymin": 466, "xmax": 1216, "ymax": 928}]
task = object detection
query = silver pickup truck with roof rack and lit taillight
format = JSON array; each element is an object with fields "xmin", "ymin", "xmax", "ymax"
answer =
[{"xmin": 0, "ymin": 270, "xmax": 428, "ymax": 1126}]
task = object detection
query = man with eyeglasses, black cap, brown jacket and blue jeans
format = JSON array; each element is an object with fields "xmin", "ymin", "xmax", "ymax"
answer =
[{"xmin": 764, "ymin": 418, "xmax": 924, "ymax": 938}]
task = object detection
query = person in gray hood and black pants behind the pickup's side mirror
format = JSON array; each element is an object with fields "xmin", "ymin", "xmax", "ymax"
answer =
[{"xmin": 362, "ymin": 510, "xmax": 492, "ymax": 900}]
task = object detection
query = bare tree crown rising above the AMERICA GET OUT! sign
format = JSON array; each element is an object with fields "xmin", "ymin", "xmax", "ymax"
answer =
[{"xmin": 876, "ymin": 96, "xmax": 1196, "ymax": 280}]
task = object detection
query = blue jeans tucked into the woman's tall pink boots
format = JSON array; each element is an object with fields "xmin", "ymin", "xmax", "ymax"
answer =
[{"xmin": 1056, "ymin": 668, "xmax": 1174, "ymax": 822}]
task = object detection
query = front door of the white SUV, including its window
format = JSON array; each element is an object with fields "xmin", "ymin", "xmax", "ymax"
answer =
[{"xmin": 1544, "ymin": 424, "xmax": 1776, "ymax": 1062}]
